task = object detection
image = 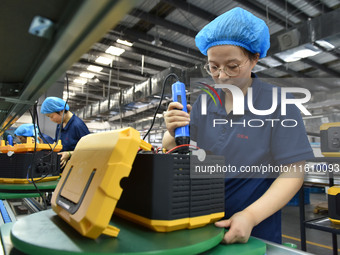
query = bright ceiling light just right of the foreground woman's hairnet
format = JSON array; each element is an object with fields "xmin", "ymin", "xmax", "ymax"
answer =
[{"xmin": 275, "ymin": 44, "xmax": 321, "ymax": 62}]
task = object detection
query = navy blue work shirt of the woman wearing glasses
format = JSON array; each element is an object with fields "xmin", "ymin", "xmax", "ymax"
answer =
[{"xmin": 190, "ymin": 75, "xmax": 314, "ymax": 243}]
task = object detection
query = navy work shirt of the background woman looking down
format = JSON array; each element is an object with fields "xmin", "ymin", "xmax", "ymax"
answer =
[{"xmin": 55, "ymin": 114, "xmax": 90, "ymax": 151}]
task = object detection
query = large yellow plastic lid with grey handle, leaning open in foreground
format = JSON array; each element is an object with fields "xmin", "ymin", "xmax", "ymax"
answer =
[{"xmin": 52, "ymin": 128, "xmax": 152, "ymax": 239}]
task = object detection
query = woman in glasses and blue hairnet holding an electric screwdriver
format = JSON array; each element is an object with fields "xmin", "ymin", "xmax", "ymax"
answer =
[{"xmin": 163, "ymin": 8, "xmax": 314, "ymax": 243}]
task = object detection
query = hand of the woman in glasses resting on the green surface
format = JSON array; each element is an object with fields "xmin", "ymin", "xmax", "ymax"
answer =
[{"xmin": 215, "ymin": 211, "xmax": 255, "ymax": 244}]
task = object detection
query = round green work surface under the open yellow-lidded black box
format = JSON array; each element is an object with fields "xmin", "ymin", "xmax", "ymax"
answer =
[{"xmin": 9, "ymin": 210, "xmax": 224, "ymax": 255}]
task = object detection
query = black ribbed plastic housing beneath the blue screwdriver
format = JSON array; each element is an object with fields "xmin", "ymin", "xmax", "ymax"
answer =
[{"xmin": 116, "ymin": 154, "xmax": 224, "ymax": 220}]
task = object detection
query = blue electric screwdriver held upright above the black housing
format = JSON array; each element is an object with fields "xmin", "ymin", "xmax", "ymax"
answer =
[{"xmin": 172, "ymin": 81, "xmax": 190, "ymax": 150}]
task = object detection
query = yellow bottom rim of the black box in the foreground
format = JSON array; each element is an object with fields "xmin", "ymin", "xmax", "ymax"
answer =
[{"xmin": 114, "ymin": 208, "xmax": 224, "ymax": 232}]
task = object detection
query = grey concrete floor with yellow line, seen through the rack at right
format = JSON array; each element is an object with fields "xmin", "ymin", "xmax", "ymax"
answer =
[{"xmin": 282, "ymin": 193, "xmax": 340, "ymax": 255}]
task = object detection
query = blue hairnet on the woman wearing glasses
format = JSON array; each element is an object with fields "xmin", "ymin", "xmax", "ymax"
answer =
[{"xmin": 195, "ymin": 7, "xmax": 270, "ymax": 58}]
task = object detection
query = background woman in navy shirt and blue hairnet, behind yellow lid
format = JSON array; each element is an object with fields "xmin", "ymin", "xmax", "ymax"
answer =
[{"xmin": 40, "ymin": 97, "xmax": 90, "ymax": 167}]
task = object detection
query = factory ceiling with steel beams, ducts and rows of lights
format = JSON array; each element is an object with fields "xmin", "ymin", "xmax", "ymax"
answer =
[{"xmin": 0, "ymin": 0, "xmax": 340, "ymax": 134}]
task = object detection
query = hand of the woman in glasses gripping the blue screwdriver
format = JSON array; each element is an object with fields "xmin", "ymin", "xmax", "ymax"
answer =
[{"xmin": 164, "ymin": 102, "xmax": 191, "ymax": 136}]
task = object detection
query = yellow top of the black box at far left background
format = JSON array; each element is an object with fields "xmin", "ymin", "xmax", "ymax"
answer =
[{"xmin": 0, "ymin": 137, "xmax": 63, "ymax": 153}]
